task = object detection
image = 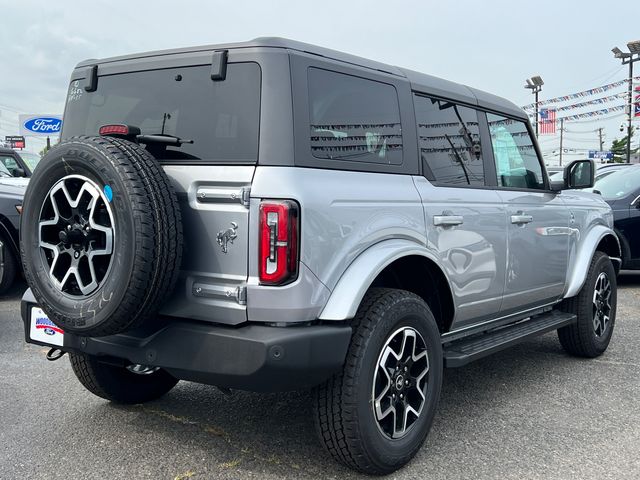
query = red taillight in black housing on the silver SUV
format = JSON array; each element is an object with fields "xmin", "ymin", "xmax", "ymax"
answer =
[{"xmin": 258, "ymin": 200, "xmax": 300, "ymax": 285}]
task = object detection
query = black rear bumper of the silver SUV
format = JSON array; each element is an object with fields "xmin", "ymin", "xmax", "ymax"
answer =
[{"xmin": 21, "ymin": 292, "xmax": 351, "ymax": 392}]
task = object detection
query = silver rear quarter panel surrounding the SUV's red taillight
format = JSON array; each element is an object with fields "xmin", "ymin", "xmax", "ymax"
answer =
[{"xmin": 247, "ymin": 166, "xmax": 426, "ymax": 322}]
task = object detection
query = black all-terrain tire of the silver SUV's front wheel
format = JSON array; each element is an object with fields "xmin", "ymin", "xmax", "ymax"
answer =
[{"xmin": 558, "ymin": 251, "xmax": 617, "ymax": 358}]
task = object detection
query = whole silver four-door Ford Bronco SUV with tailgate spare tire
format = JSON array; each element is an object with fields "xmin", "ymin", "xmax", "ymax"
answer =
[{"xmin": 21, "ymin": 38, "xmax": 620, "ymax": 474}]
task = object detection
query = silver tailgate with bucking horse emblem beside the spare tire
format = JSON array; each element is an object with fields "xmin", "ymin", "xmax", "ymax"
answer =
[{"xmin": 161, "ymin": 165, "xmax": 255, "ymax": 324}]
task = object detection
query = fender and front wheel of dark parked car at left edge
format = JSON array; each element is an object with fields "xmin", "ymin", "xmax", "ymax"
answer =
[{"xmin": 0, "ymin": 176, "xmax": 28, "ymax": 295}]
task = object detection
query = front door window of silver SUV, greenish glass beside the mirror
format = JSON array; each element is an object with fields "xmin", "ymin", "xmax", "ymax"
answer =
[{"xmin": 487, "ymin": 113, "xmax": 545, "ymax": 190}]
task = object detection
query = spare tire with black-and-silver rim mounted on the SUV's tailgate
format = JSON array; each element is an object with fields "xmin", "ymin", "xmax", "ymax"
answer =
[{"xmin": 20, "ymin": 137, "xmax": 182, "ymax": 336}]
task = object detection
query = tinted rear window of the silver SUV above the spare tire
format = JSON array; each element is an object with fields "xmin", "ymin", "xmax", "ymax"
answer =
[{"xmin": 62, "ymin": 63, "xmax": 261, "ymax": 163}]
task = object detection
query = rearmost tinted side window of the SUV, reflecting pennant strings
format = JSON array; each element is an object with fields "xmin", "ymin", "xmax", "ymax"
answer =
[{"xmin": 308, "ymin": 68, "xmax": 402, "ymax": 165}]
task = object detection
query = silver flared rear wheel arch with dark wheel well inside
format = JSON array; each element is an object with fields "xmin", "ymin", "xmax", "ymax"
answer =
[{"xmin": 319, "ymin": 240, "xmax": 455, "ymax": 333}]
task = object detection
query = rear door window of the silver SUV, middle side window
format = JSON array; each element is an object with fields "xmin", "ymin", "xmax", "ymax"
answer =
[{"xmin": 414, "ymin": 95, "xmax": 484, "ymax": 186}]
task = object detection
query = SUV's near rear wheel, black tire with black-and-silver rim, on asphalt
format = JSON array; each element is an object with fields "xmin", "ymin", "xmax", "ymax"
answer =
[{"xmin": 314, "ymin": 289, "xmax": 442, "ymax": 475}]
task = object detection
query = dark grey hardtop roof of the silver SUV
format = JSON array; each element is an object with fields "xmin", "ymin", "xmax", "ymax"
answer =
[{"xmin": 76, "ymin": 37, "xmax": 527, "ymax": 119}]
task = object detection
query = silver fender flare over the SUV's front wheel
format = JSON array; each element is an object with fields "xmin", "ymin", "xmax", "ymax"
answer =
[{"xmin": 564, "ymin": 225, "xmax": 622, "ymax": 298}]
